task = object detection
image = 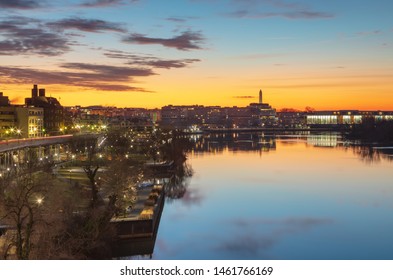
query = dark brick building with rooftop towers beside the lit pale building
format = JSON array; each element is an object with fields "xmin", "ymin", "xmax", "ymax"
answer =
[{"xmin": 25, "ymin": 85, "xmax": 64, "ymax": 134}]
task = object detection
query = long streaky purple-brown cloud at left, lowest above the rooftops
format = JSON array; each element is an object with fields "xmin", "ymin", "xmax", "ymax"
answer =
[{"xmin": 0, "ymin": 63, "xmax": 154, "ymax": 91}]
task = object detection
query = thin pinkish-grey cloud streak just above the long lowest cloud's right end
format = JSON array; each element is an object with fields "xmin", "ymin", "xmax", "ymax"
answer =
[{"xmin": 104, "ymin": 50, "xmax": 200, "ymax": 69}]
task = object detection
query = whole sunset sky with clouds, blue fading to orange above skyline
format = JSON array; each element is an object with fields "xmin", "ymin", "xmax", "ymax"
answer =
[{"xmin": 0, "ymin": 0, "xmax": 393, "ymax": 110}]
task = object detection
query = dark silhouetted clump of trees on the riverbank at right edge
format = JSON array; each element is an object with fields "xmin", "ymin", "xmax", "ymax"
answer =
[{"xmin": 348, "ymin": 118, "xmax": 393, "ymax": 142}]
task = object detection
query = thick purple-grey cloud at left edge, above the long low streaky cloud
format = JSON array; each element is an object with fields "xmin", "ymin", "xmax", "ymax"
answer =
[{"xmin": 0, "ymin": 17, "xmax": 70, "ymax": 56}]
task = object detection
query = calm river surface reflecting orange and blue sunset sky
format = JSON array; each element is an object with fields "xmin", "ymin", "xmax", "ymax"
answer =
[{"xmin": 153, "ymin": 135, "xmax": 393, "ymax": 260}]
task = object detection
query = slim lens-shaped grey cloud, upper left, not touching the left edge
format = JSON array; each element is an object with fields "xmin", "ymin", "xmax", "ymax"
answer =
[{"xmin": 47, "ymin": 18, "xmax": 126, "ymax": 32}]
